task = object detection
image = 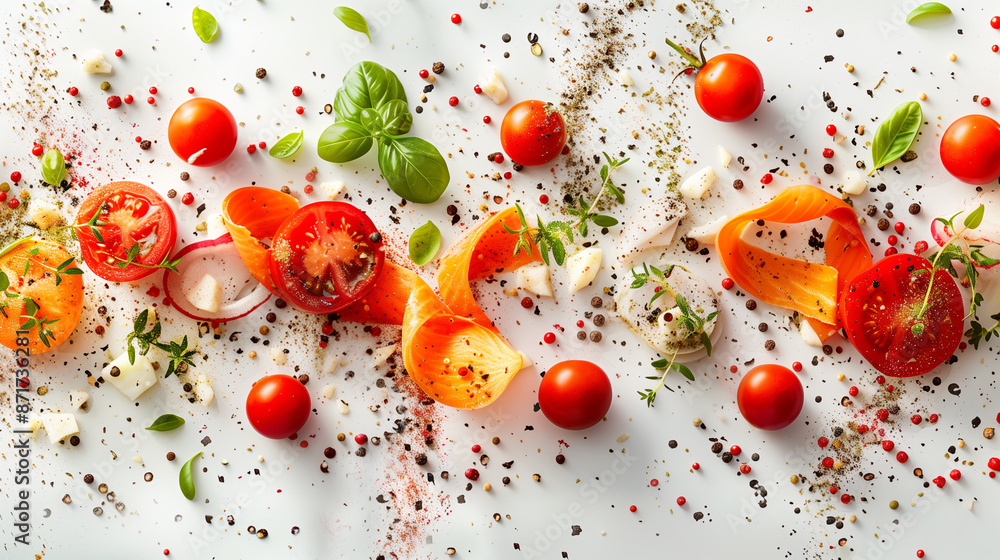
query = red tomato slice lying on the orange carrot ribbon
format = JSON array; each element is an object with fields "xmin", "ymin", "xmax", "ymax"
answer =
[{"xmin": 269, "ymin": 201, "xmax": 385, "ymax": 313}]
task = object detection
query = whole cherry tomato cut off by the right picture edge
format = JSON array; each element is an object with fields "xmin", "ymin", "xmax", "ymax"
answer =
[{"xmin": 941, "ymin": 115, "xmax": 1000, "ymax": 185}]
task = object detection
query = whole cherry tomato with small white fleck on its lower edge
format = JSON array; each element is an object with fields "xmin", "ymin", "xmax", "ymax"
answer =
[{"xmin": 168, "ymin": 97, "xmax": 238, "ymax": 167}]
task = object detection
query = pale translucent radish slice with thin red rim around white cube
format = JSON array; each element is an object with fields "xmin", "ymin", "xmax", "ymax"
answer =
[{"xmin": 163, "ymin": 233, "xmax": 271, "ymax": 323}]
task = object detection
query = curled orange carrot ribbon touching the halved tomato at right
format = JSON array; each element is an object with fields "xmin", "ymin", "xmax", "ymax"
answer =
[{"xmin": 716, "ymin": 185, "xmax": 872, "ymax": 328}]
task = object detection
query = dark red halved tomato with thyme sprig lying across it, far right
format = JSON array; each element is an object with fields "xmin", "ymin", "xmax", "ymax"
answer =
[{"xmin": 840, "ymin": 253, "xmax": 965, "ymax": 377}]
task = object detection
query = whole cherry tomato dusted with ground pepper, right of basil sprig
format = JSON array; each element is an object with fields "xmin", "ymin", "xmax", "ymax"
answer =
[{"xmin": 500, "ymin": 100, "xmax": 566, "ymax": 165}]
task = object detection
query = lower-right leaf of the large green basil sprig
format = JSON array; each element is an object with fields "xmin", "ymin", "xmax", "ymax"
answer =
[{"xmin": 378, "ymin": 137, "xmax": 451, "ymax": 204}]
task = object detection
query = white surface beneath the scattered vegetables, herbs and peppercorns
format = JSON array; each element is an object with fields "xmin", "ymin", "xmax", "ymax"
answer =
[{"xmin": 0, "ymin": 0, "xmax": 1000, "ymax": 560}]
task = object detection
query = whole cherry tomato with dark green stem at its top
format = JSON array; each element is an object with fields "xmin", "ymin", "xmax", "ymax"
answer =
[{"xmin": 694, "ymin": 53, "xmax": 764, "ymax": 122}]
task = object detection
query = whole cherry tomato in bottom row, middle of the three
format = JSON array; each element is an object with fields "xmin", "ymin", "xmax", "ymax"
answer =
[{"xmin": 538, "ymin": 360, "xmax": 611, "ymax": 430}]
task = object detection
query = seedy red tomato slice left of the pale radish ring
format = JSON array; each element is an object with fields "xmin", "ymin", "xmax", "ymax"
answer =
[{"xmin": 75, "ymin": 181, "xmax": 177, "ymax": 282}]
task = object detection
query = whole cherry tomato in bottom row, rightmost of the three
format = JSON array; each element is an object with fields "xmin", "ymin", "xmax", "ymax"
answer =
[{"xmin": 736, "ymin": 364, "xmax": 805, "ymax": 430}]
